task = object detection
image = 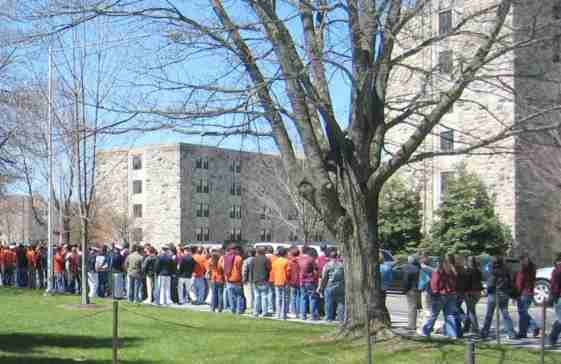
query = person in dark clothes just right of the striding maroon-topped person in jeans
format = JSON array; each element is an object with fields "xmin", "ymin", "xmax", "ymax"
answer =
[{"xmin": 463, "ymin": 257, "xmax": 483, "ymax": 335}]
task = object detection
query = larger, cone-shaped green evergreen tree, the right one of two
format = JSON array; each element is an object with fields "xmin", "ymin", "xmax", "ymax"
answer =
[{"xmin": 431, "ymin": 167, "xmax": 509, "ymax": 255}]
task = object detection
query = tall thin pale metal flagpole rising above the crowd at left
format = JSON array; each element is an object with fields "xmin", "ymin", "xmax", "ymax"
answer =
[{"xmin": 47, "ymin": 46, "xmax": 54, "ymax": 293}]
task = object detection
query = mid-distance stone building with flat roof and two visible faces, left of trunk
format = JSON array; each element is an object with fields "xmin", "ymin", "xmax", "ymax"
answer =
[{"xmin": 96, "ymin": 143, "xmax": 323, "ymax": 245}]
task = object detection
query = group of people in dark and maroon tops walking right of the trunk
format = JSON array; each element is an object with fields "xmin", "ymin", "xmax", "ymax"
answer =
[{"xmin": 394, "ymin": 255, "xmax": 548, "ymax": 343}]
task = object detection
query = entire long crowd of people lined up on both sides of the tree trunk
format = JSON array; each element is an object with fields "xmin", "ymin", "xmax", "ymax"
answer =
[{"xmin": 5, "ymin": 244, "xmax": 561, "ymax": 344}]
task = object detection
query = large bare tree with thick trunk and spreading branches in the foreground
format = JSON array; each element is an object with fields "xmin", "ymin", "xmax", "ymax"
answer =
[{"xmin": 31, "ymin": 0, "xmax": 560, "ymax": 334}]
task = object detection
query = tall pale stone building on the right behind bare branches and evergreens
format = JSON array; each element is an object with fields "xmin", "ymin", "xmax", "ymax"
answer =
[{"xmin": 391, "ymin": 0, "xmax": 561, "ymax": 264}]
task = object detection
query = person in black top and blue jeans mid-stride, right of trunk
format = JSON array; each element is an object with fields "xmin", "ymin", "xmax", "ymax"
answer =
[{"xmin": 481, "ymin": 256, "xmax": 517, "ymax": 340}]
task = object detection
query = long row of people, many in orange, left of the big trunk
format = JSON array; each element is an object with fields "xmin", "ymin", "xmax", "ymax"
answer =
[{"xmin": 0, "ymin": 244, "xmax": 345, "ymax": 321}]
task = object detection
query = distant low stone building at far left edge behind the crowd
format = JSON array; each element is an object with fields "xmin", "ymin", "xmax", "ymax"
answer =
[{"xmin": 0, "ymin": 194, "xmax": 47, "ymax": 244}]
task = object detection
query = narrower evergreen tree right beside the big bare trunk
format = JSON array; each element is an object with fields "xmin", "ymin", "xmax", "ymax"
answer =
[{"xmin": 379, "ymin": 177, "xmax": 422, "ymax": 254}]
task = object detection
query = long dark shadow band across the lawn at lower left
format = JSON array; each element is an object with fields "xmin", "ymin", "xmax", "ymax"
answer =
[{"xmin": 0, "ymin": 333, "xmax": 143, "ymax": 354}]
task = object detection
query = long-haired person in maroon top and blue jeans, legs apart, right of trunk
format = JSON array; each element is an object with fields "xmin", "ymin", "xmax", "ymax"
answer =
[{"xmin": 420, "ymin": 257, "xmax": 458, "ymax": 338}]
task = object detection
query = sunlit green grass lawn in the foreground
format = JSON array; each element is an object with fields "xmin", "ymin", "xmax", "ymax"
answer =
[{"xmin": 0, "ymin": 288, "xmax": 561, "ymax": 364}]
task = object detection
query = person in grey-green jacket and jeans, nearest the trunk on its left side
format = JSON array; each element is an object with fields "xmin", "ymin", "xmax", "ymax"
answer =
[{"xmin": 318, "ymin": 248, "xmax": 345, "ymax": 322}]
